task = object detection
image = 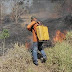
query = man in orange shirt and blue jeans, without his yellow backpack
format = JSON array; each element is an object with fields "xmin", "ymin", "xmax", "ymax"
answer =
[{"xmin": 27, "ymin": 16, "xmax": 47, "ymax": 65}]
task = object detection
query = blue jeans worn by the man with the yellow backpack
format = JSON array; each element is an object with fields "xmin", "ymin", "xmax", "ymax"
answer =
[{"xmin": 32, "ymin": 42, "xmax": 46, "ymax": 62}]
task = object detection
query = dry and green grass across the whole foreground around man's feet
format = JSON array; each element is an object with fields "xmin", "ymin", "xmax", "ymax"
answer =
[{"xmin": 0, "ymin": 31, "xmax": 72, "ymax": 72}]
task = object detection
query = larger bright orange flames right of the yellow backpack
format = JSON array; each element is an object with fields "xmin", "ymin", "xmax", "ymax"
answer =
[{"xmin": 53, "ymin": 30, "xmax": 66, "ymax": 42}]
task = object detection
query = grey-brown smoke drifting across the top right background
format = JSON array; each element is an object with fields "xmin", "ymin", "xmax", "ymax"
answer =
[{"xmin": 31, "ymin": 0, "xmax": 72, "ymax": 18}]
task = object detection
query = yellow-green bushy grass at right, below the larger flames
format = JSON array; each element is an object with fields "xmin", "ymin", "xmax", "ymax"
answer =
[{"xmin": 45, "ymin": 32, "xmax": 72, "ymax": 72}]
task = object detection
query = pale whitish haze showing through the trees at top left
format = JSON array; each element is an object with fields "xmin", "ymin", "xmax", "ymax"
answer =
[{"xmin": 2, "ymin": 0, "xmax": 33, "ymax": 14}]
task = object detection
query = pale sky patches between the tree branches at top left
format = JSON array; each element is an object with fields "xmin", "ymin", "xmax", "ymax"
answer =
[{"xmin": 2, "ymin": 0, "xmax": 33, "ymax": 14}]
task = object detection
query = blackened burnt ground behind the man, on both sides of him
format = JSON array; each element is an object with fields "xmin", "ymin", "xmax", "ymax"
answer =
[{"xmin": 0, "ymin": 15, "xmax": 72, "ymax": 53}]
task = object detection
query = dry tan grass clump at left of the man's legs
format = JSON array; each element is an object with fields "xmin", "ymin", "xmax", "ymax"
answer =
[{"xmin": 0, "ymin": 44, "xmax": 32, "ymax": 72}]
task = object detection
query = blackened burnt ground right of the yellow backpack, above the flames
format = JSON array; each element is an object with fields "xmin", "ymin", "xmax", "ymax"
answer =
[{"xmin": 43, "ymin": 15, "xmax": 72, "ymax": 40}]
